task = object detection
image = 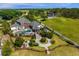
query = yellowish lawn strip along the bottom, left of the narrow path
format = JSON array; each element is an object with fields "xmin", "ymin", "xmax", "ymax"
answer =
[{"xmin": 11, "ymin": 50, "xmax": 45, "ymax": 56}]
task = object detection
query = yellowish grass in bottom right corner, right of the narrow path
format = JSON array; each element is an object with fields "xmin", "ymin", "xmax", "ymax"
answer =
[{"xmin": 50, "ymin": 46, "xmax": 79, "ymax": 56}]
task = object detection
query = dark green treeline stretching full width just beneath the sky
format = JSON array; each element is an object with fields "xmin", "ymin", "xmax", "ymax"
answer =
[{"xmin": 0, "ymin": 8, "xmax": 79, "ymax": 20}]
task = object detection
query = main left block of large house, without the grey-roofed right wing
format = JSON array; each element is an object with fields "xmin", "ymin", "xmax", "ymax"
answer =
[{"xmin": 11, "ymin": 17, "xmax": 33, "ymax": 35}]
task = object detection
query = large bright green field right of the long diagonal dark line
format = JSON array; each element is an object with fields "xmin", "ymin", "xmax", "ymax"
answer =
[{"xmin": 43, "ymin": 17, "xmax": 79, "ymax": 44}]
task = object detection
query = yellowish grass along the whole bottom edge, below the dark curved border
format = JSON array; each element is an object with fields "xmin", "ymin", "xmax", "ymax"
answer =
[{"xmin": 11, "ymin": 46, "xmax": 79, "ymax": 56}]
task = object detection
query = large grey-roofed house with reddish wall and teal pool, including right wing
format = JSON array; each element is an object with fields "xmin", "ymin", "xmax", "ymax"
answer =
[{"xmin": 11, "ymin": 17, "xmax": 43, "ymax": 35}]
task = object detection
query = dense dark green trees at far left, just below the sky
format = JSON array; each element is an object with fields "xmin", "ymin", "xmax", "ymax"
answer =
[{"xmin": 0, "ymin": 9, "xmax": 22, "ymax": 20}]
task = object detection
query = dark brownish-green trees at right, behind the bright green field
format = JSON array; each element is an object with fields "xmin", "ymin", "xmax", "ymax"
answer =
[{"xmin": 49, "ymin": 8, "xmax": 79, "ymax": 18}]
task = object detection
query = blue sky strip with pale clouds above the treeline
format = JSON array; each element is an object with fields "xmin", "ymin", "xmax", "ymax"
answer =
[{"xmin": 0, "ymin": 3, "xmax": 79, "ymax": 9}]
